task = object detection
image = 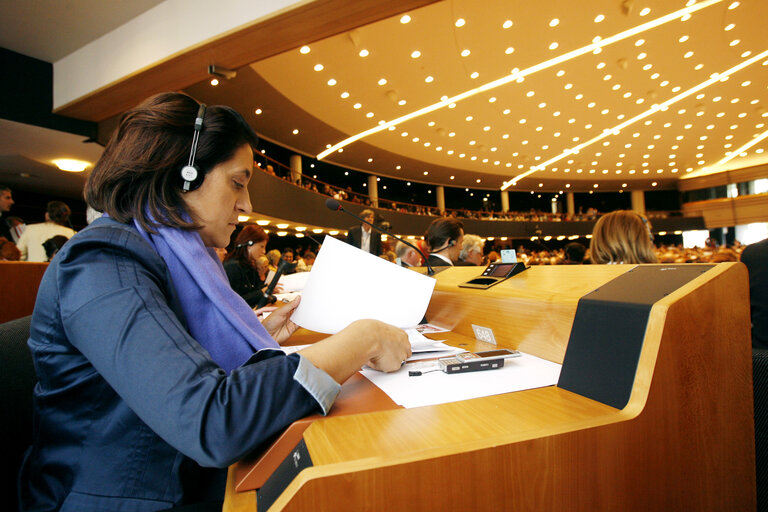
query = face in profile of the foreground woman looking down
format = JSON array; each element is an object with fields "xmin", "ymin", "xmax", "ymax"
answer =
[{"xmin": 182, "ymin": 145, "xmax": 253, "ymax": 247}]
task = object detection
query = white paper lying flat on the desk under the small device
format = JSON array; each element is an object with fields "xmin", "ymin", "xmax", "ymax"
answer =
[{"xmin": 361, "ymin": 354, "xmax": 561, "ymax": 408}]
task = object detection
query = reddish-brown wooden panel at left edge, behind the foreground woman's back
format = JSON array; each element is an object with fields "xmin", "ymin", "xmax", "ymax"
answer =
[{"xmin": 0, "ymin": 261, "xmax": 48, "ymax": 323}]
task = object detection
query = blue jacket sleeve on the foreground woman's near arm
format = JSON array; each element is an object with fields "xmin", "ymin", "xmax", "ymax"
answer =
[{"xmin": 56, "ymin": 237, "xmax": 332, "ymax": 467}]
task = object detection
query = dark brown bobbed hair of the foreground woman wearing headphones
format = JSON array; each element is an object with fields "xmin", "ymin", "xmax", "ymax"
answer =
[{"xmin": 85, "ymin": 92, "xmax": 258, "ymax": 232}]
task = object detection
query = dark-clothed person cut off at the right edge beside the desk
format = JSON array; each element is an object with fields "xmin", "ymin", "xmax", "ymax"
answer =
[{"xmin": 741, "ymin": 238, "xmax": 768, "ymax": 348}]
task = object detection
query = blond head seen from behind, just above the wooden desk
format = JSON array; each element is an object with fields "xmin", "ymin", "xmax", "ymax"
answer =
[{"xmin": 589, "ymin": 210, "xmax": 657, "ymax": 264}]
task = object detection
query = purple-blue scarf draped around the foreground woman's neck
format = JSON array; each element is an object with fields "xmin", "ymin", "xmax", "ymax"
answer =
[{"xmin": 133, "ymin": 220, "xmax": 280, "ymax": 374}]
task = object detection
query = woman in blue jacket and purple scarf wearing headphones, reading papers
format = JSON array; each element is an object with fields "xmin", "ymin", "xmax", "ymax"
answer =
[{"xmin": 19, "ymin": 93, "xmax": 411, "ymax": 512}]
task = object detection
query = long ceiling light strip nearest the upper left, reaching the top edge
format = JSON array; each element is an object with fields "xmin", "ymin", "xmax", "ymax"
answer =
[{"xmin": 316, "ymin": 0, "xmax": 724, "ymax": 160}]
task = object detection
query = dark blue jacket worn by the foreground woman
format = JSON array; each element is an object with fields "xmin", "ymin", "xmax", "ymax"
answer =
[{"xmin": 20, "ymin": 219, "xmax": 330, "ymax": 511}]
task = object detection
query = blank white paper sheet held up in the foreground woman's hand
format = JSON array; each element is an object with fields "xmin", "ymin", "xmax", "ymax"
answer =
[{"xmin": 291, "ymin": 236, "xmax": 435, "ymax": 334}]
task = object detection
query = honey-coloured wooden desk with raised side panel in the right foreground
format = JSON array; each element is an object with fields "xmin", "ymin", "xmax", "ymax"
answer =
[{"xmin": 225, "ymin": 263, "xmax": 756, "ymax": 511}]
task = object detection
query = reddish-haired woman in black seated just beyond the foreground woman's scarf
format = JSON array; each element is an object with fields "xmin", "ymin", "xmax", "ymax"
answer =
[{"xmin": 224, "ymin": 224, "xmax": 269, "ymax": 307}]
